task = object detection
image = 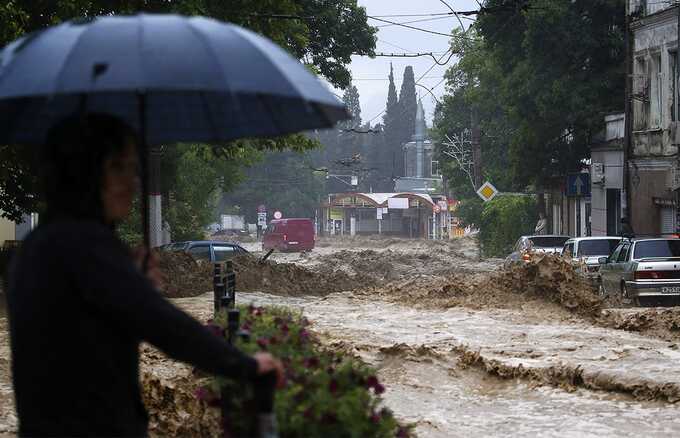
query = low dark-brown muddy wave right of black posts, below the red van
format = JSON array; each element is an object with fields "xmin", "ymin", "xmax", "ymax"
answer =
[{"xmin": 233, "ymin": 256, "xmax": 373, "ymax": 296}]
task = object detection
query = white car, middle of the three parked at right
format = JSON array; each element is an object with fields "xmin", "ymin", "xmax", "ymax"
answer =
[{"xmin": 562, "ymin": 236, "xmax": 621, "ymax": 281}]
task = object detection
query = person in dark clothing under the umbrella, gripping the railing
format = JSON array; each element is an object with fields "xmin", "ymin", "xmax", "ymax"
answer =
[{"xmin": 7, "ymin": 114, "xmax": 283, "ymax": 436}]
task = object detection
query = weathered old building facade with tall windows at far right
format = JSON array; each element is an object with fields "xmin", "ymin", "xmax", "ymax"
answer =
[{"xmin": 627, "ymin": 0, "xmax": 680, "ymax": 234}]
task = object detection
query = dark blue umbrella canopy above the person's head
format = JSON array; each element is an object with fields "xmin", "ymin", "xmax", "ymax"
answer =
[{"xmin": 0, "ymin": 14, "xmax": 348, "ymax": 145}]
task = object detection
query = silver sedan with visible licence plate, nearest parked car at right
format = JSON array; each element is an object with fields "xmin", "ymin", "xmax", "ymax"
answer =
[{"xmin": 599, "ymin": 238, "xmax": 680, "ymax": 306}]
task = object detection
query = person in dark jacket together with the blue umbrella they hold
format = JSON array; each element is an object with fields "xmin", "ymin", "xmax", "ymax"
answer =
[{"xmin": 0, "ymin": 14, "xmax": 350, "ymax": 436}]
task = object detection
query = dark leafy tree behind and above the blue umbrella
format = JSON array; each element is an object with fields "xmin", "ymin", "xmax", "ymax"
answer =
[{"xmin": 0, "ymin": 0, "xmax": 376, "ymax": 220}]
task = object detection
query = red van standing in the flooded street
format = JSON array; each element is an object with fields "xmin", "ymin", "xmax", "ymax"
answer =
[{"xmin": 262, "ymin": 218, "xmax": 314, "ymax": 252}]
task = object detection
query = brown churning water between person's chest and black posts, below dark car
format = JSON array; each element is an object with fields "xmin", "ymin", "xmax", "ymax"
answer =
[{"xmin": 158, "ymin": 251, "xmax": 213, "ymax": 298}]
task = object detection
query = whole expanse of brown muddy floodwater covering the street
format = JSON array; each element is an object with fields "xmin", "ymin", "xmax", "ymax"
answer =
[{"xmin": 0, "ymin": 237, "xmax": 680, "ymax": 438}]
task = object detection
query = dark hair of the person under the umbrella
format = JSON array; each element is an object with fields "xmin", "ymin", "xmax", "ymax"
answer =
[{"xmin": 39, "ymin": 113, "xmax": 136, "ymax": 222}]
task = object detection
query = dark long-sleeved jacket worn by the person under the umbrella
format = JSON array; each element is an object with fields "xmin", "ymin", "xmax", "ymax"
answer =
[{"xmin": 7, "ymin": 221, "xmax": 257, "ymax": 436}]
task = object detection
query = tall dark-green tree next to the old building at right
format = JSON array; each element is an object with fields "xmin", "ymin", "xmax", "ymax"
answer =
[{"xmin": 476, "ymin": 0, "xmax": 625, "ymax": 187}]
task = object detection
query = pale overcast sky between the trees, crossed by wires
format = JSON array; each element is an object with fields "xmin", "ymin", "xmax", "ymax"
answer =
[{"xmin": 338, "ymin": 0, "xmax": 479, "ymax": 126}]
